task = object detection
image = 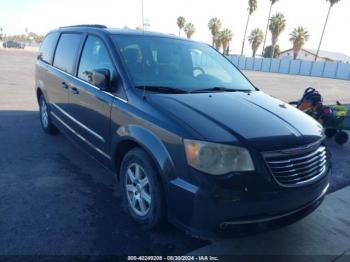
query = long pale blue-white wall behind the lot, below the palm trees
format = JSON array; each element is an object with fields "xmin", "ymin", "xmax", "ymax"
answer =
[{"xmin": 228, "ymin": 56, "xmax": 350, "ymax": 80}]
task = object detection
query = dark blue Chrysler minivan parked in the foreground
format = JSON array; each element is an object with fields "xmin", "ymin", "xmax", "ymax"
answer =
[{"xmin": 35, "ymin": 25, "xmax": 331, "ymax": 235}]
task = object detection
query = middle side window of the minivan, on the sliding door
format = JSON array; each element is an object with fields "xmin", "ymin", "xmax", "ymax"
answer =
[{"xmin": 53, "ymin": 34, "xmax": 82, "ymax": 74}]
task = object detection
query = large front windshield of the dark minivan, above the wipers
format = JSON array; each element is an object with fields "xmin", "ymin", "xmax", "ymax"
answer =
[{"xmin": 113, "ymin": 35, "xmax": 255, "ymax": 92}]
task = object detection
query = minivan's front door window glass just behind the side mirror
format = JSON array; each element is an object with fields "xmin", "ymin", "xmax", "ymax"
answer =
[{"xmin": 78, "ymin": 36, "xmax": 114, "ymax": 83}]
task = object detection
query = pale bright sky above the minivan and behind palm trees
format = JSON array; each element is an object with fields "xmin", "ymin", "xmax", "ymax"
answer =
[{"xmin": 0, "ymin": 0, "xmax": 350, "ymax": 55}]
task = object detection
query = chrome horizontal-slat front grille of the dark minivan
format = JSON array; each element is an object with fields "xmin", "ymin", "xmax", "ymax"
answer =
[{"xmin": 263, "ymin": 144, "xmax": 329, "ymax": 186}]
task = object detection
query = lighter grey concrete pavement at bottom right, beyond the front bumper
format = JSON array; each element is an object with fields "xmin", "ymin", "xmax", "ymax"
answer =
[{"xmin": 188, "ymin": 187, "xmax": 350, "ymax": 262}]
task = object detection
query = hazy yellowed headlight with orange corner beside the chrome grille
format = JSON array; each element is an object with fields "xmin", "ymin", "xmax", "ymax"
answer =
[{"xmin": 184, "ymin": 139, "xmax": 254, "ymax": 175}]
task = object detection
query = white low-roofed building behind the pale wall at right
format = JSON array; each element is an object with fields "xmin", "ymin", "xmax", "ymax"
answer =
[{"xmin": 280, "ymin": 48, "xmax": 350, "ymax": 63}]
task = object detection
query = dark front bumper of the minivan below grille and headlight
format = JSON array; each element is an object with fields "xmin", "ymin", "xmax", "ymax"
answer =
[{"xmin": 169, "ymin": 169, "xmax": 331, "ymax": 237}]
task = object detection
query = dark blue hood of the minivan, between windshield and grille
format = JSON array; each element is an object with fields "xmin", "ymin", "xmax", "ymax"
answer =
[{"xmin": 150, "ymin": 91, "xmax": 323, "ymax": 151}]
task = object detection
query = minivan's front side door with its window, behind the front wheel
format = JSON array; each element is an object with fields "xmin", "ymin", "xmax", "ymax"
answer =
[{"xmin": 65, "ymin": 35, "xmax": 115, "ymax": 159}]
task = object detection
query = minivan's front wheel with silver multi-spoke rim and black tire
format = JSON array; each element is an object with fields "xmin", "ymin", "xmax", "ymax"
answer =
[{"xmin": 120, "ymin": 148, "xmax": 165, "ymax": 228}]
